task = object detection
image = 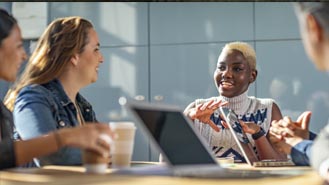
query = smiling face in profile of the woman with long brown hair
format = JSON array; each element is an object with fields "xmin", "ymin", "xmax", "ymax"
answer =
[{"xmin": 78, "ymin": 28, "xmax": 104, "ymax": 84}]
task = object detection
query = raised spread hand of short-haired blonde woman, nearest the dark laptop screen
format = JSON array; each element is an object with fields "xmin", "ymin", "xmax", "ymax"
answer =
[{"xmin": 184, "ymin": 98, "xmax": 228, "ymax": 132}]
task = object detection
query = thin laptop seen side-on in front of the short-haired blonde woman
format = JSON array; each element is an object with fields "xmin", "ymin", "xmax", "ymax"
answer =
[{"xmin": 220, "ymin": 107, "xmax": 295, "ymax": 167}]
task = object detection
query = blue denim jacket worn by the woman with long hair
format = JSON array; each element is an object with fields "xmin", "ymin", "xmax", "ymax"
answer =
[{"xmin": 13, "ymin": 79, "xmax": 97, "ymax": 165}]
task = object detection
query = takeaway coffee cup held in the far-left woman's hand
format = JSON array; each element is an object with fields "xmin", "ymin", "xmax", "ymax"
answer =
[{"xmin": 82, "ymin": 135, "xmax": 112, "ymax": 174}]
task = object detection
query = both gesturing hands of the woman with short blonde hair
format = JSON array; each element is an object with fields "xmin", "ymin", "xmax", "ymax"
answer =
[{"xmin": 184, "ymin": 98, "xmax": 260, "ymax": 134}]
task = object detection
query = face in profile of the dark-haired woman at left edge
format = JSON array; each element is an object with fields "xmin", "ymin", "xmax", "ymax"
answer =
[{"xmin": 0, "ymin": 25, "xmax": 27, "ymax": 82}]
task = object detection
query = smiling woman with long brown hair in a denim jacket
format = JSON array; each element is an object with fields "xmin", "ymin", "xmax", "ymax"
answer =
[{"xmin": 1, "ymin": 14, "xmax": 108, "ymax": 165}]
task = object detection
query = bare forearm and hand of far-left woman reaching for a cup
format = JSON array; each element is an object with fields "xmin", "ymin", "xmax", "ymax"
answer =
[{"xmin": 14, "ymin": 124, "xmax": 112, "ymax": 165}]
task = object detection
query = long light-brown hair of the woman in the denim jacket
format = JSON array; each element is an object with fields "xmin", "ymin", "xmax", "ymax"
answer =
[{"xmin": 5, "ymin": 16, "xmax": 93, "ymax": 110}]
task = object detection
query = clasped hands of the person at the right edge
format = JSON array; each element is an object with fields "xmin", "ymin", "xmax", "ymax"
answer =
[{"xmin": 269, "ymin": 111, "xmax": 311, "ymax": 154}]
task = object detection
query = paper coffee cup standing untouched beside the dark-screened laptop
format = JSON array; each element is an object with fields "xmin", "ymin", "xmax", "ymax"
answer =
[{"xmin": 110, "ymin": 122, "xmax": 136, "ymax": 168}]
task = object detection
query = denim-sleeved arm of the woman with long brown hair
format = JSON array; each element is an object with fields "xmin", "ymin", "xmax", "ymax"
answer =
[{"xmin": 14, "ymin": 89, "xmax": 86, "ymax": 165}]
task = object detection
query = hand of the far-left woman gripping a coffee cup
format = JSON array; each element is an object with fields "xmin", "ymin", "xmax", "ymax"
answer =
[{"xmin": 55, "ymin": 123, "xmax": 114, "ymax": 157}]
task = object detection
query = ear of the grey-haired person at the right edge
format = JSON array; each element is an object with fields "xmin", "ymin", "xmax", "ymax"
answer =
[{"xmin": 306, "ymin": 14, "xmax": 324, "ymax": 44}]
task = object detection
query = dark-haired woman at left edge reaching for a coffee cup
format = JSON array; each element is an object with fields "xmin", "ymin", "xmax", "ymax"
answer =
[{"xmin": 0, "ymin": 9, "xmax": 112, "ymax": 169}]
